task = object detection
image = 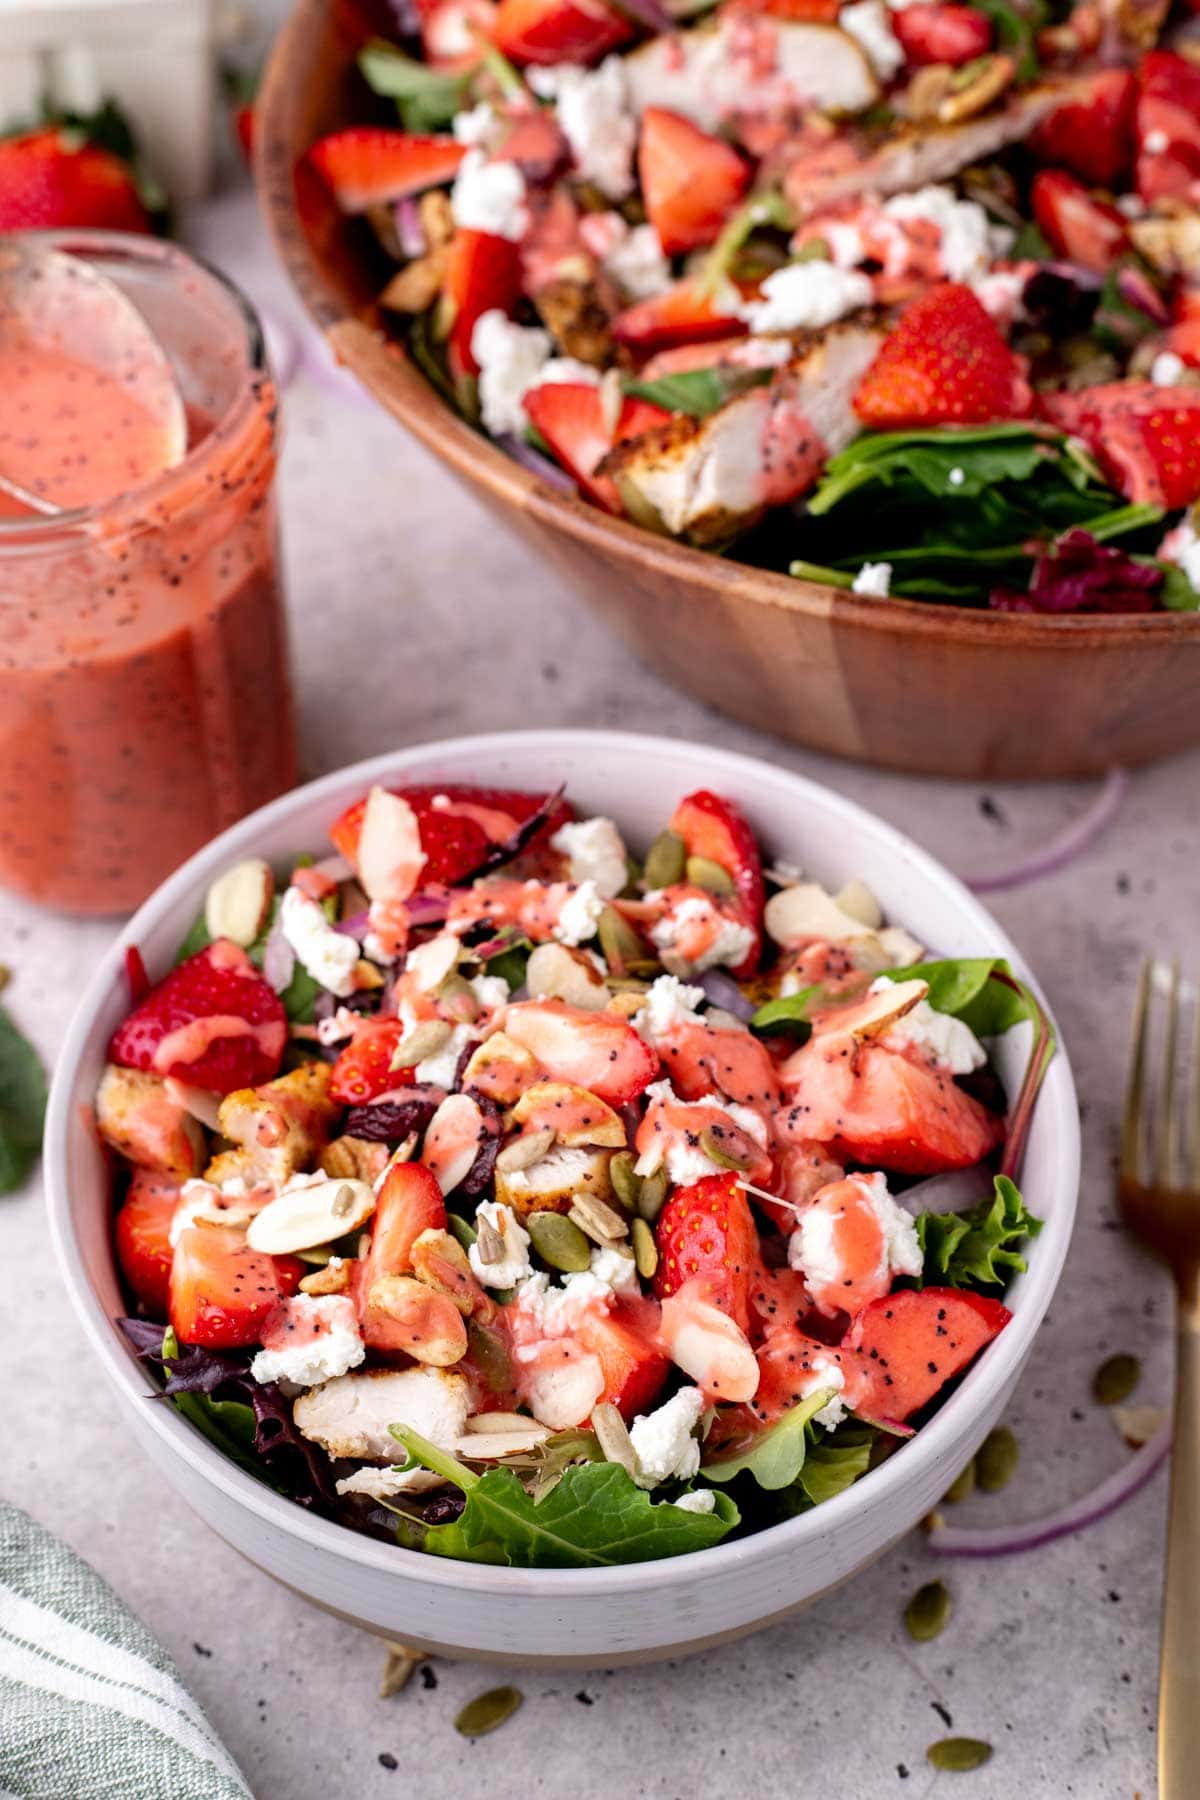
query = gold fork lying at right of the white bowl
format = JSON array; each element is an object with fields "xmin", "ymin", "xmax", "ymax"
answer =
[{"xmin": 1117, "ymin": 958, "xmax": 1200, "ymax": 1800}]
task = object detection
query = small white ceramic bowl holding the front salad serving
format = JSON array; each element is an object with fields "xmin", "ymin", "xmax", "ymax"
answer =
[{"xmin": 45, "ymin": 731, "xmax": 1079, "ymax": 1667}]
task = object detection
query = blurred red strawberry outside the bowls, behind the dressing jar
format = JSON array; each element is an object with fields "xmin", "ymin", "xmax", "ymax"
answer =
[{"xmin": 0, "ymin": 126, "xmax": 149, "ymax": 230}]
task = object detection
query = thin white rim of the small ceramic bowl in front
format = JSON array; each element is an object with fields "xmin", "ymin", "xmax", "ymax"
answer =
[{"xmin": 43, "ymin": 727, "xmax": 1079, "ymax": 1598}]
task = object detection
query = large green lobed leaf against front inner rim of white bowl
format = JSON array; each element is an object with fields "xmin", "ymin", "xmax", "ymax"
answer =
[{"xmin": 392, "ymin": 1426, "xmax": 739, "ymax": 1568}]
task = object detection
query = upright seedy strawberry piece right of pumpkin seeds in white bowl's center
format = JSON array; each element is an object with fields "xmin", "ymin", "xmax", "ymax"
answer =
[{"xmin": 655, "ymin": 1174, "xmax": 759, "ymax": 1332}]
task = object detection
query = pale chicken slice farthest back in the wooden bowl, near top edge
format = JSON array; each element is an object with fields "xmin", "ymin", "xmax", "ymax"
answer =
[{"xmin": 624, "ymin": 9, "xmax": 880, "ymax": 131}]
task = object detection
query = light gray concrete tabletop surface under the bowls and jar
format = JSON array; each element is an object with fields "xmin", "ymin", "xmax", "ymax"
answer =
[{"xmin": 0, "ymin": 175, "xmax": 1200, "ymax": 1800}]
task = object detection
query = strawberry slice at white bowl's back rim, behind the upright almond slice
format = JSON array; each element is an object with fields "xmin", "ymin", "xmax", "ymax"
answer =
[{"xmin": 329, "ymin": 781, "xmax": 574, "ymax": 887}]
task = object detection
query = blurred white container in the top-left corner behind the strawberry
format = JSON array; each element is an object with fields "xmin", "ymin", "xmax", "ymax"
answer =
[{"xmin": 0, "ymin": 0, "xmax": 216, "ymax": 202}]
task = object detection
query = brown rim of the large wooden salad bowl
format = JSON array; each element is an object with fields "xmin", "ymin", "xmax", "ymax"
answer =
[{"xmin": 254, "ymin": 0, "xmax": 1200, "ymax": 648}]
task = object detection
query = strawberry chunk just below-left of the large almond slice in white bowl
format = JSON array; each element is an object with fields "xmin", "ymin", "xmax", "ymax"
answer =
[{"xmin": 169, "ymin": 1226, "xmax": 304, "ymax": 1350}]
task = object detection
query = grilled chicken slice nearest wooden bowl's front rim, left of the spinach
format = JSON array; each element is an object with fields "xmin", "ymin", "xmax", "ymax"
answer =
[{"xmin": 601, "ymin": 320, "xmax": 883, "ymax": 547}]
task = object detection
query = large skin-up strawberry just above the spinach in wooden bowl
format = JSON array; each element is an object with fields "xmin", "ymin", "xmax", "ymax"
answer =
[{"xmin": 855, "ymin": 281, "xmax": 1033, "ymax": 430}]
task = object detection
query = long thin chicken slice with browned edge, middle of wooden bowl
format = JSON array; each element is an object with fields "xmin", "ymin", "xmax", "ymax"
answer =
[{"xmin": 783, "ymin": 77, "xmax": 1087, "ymax": 220}]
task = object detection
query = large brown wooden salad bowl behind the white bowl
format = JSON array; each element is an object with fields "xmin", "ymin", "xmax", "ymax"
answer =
[{"xmin": 255, "ymin": 0, "xmax": 1200, "ymax": 779}]
